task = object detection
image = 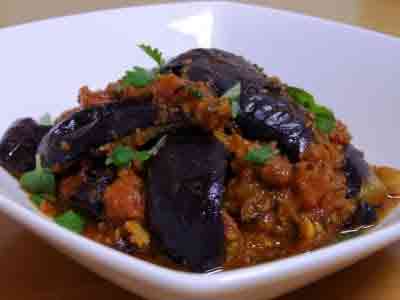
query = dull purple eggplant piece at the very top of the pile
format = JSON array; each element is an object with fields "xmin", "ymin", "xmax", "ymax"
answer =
[{"xmin": 161, "ymin": 48, "xmax": 268, "ymax": 96}]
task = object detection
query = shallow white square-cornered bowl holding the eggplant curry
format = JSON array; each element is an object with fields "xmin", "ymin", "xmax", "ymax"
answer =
[{"xmin": 0, "ymin": 2, "xmax": 400, "ymax": 300}]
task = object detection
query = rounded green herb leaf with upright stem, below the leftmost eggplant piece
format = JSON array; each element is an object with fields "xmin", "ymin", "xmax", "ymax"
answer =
[{"xmin": 19, "ymin": 155, "xmax": 56, "ymax": 195}]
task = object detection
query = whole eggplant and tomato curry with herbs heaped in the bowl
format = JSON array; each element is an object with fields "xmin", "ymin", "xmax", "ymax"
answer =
[{"xmin": 0, "ymin": 45, "xmax": 400, "ymax": 272}]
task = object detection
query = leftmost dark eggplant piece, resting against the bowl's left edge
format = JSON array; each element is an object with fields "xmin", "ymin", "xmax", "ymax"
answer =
[{"xmin": 0, "ymin": 118, "xmax": 51, "ymax": 176}]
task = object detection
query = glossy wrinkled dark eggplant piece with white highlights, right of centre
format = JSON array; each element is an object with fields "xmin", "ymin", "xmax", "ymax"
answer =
[{"xmin": 236, "ymin": 94, "xmax": 312, "ymax": 162}]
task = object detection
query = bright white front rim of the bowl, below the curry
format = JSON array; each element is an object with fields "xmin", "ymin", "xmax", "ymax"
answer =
[{"xmin": 0, "ymin": 190, "xmax": 400, "ymax": 292}]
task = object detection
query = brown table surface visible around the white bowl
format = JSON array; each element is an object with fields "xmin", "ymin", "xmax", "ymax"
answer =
[{"xmin": 0, "ymin": 0, "xmax": 400, "ymax": 300}]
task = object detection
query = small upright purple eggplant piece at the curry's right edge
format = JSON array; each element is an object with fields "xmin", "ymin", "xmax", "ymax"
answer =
[{"xmin": 343, "ymin": 144, "xmax": 370, "ymax": 198}]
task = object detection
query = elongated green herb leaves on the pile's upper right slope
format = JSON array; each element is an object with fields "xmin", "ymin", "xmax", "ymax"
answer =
[{"xmin": 287, "ymin": 86, "xmax": 336, "ymax": 134}]
